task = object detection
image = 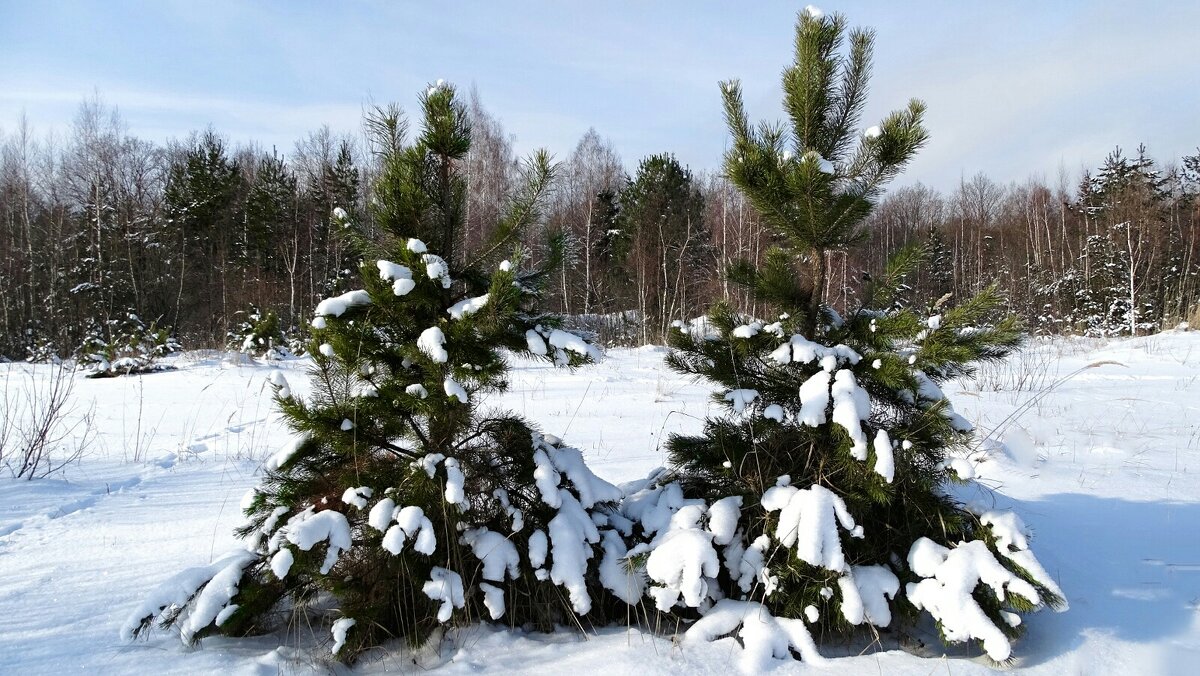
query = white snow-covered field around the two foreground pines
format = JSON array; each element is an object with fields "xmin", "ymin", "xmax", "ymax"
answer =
[{"xmin": 0, "ymin": 333, "xmax": 1200, "ymax": 675}]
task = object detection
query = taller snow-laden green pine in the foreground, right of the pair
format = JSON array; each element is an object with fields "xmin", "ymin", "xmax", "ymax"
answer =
[{"xmin": 643, "ymin": 7, "xmax": 1063, "ymax": 670}]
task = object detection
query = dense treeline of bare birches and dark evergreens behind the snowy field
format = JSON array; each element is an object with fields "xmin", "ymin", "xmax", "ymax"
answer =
[{"xmin": 0, "ymin": 95, "xmax": 1200, "ymax": 359}]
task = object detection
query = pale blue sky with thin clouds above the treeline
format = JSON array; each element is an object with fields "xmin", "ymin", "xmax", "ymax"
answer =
[{"xmin": 0, "ymin": 0, "xmax": 1200, "ymax": 189}]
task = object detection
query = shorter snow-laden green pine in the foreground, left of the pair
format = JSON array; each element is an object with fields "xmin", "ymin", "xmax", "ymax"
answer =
[{"xmin": 125, "ymin": 82, "xmax": 641, "ymax": 659}]
